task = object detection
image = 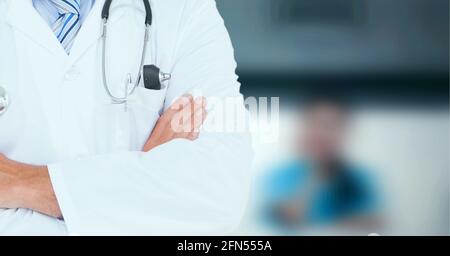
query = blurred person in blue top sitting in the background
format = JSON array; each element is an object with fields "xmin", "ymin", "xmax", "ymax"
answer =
[{"xmin": 263, "ymin": 96, "xmax": 380, "ymax": 232}]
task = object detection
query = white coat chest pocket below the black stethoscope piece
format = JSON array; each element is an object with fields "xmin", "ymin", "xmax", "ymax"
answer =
[{"xmin": 128, "ymin": 87, "xmax": 167, "ymax": 150}]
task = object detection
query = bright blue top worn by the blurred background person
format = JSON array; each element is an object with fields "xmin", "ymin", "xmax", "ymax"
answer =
[{"xmin": 263, "ymin": 161, "xmax": 379, "ymax": 228}]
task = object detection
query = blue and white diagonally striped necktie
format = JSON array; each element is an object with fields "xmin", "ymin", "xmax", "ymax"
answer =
[{"xmin": 51, "ymin": 0, "xmax": 81, "ymax": 54}]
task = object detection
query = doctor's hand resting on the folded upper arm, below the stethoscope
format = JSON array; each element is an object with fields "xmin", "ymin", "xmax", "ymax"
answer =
[{"xmin": 143, "ymin": 95, "xmax": 207, "ymax": 152}]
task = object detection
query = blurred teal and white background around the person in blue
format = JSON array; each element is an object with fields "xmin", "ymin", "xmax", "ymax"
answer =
[{"xmin": 217, "ymin": 0, "xmax": 450, "ymax": 235}]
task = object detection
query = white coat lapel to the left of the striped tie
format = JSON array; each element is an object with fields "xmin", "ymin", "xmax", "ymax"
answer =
[{"xmin": 6, "ymin": 0, "xmax": 67, "ymax": 58}]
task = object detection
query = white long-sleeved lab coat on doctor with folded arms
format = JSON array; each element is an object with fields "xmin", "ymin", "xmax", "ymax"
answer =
[{"xmin": 0, "ymin": 0, "xmax": 252, "ymax": 235}]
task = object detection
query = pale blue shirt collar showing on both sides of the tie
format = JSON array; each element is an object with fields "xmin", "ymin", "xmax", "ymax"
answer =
[{"xmin": 33, "ymin": 0, "xmax": 95, "ymax": 27}]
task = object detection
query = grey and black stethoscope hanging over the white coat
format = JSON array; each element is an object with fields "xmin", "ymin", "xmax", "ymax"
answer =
[{"xmin": 0, "ymin": 0, "xmax": 171, "ymax": 116}]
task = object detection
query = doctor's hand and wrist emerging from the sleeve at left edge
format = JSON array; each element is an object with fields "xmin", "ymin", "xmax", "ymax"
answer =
[{"xmin": 0, "ymin": 154, "xmax": 62, "ymax": 217}]
